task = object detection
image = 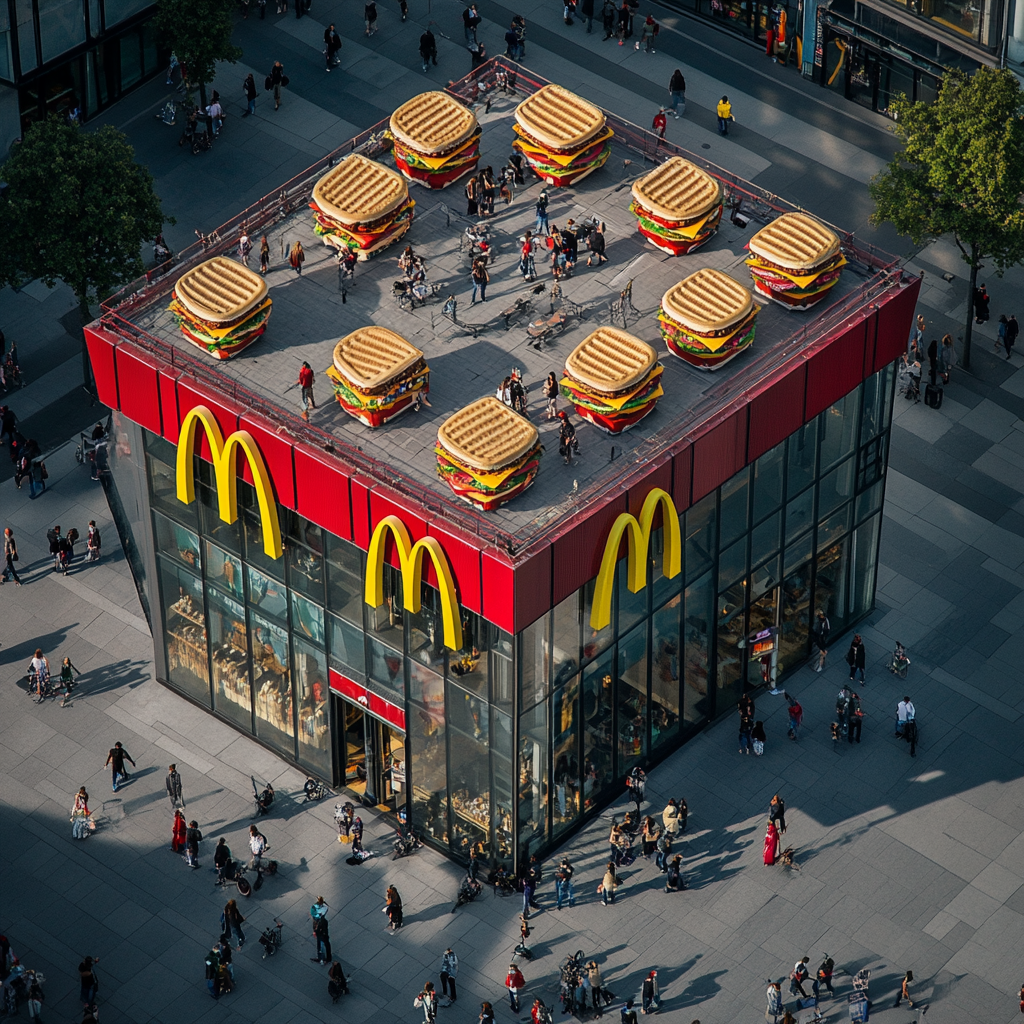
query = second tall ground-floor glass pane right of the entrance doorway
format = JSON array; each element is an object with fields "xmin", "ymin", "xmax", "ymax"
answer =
[{"xmin": 446, "ymin": 683, "xmax": 490, "ymax": 860}]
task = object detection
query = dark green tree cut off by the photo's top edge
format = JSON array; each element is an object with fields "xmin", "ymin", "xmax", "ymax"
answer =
[{"xmin": 157, "ymin": 0, "xmax": 242, "ymax": 137}]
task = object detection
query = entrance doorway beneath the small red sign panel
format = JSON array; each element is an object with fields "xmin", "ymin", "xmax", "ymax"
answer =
[{"xmin": 334, "ymin": 694, "xmax": 406, "ymax": 811}]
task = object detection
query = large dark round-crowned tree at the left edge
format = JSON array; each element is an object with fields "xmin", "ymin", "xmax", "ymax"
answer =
[{"xmin": 0, "ymin": 117, "xmax": 173, "ymax": 387}]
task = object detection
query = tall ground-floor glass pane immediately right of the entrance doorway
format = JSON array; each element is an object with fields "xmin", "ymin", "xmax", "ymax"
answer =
[{"xmin": 408, "ymin": 672, "xmax": 449, "ymax": 847}]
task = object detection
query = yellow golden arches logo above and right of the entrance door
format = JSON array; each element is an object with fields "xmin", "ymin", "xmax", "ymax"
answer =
[{"xmin": 365, "ymin": 515, "xmax": 462, "ymax": 650}]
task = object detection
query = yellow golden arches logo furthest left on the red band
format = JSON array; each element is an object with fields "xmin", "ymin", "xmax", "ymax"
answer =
[{"xmin": 175, "ymin": 406, "xmax": 284, "ymax": 558}]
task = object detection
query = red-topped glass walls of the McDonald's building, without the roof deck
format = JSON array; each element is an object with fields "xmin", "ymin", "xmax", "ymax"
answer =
[{"xmin": 86, "ymin": 101, "xmax": 920, "ymax": 866}]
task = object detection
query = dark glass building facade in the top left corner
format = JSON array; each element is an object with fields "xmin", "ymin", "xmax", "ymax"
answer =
[{"xmin": 0, "ymin": 0, "xmax": 161, "ymax": 153}]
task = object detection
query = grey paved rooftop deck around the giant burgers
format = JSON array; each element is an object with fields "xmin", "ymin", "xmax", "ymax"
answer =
[{"xmin": 102, "ymin": 60, "xmax": 899, "ymax": 551}]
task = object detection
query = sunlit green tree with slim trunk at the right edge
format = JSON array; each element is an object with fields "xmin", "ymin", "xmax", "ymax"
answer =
[{"xmin": 869, "ymin": 66, "xmax": 1024, "ymax": 368}]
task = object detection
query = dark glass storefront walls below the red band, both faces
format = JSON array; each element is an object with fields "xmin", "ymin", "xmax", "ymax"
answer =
[{"xmin": 112, "ymin": 368, "xmax": 894, "ymax": 863}]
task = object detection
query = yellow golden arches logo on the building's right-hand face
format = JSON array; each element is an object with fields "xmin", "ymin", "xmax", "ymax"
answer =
[{"xmin": 590, "ymin": 487, "xmax": 682, "ymax": 630}]
